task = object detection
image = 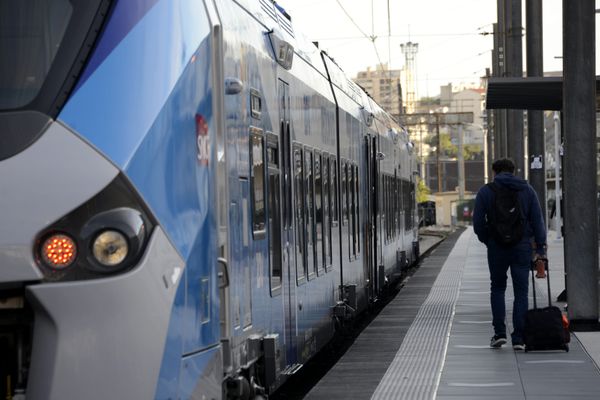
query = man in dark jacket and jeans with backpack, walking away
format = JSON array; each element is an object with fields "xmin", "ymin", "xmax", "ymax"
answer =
[{"xmin": 473, "ymin": 159, "xmax": 546, "ymax": 350}]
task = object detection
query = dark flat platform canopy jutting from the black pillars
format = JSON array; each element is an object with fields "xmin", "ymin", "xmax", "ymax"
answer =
[{"xmin": 486, "ymin": 76, "xmax": 600, "ymax": 110}]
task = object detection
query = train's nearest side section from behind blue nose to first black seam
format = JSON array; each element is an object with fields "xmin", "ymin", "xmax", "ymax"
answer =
[{"xmin": 222, "ymin": 2, "xmax": 339, "ymax": 387}]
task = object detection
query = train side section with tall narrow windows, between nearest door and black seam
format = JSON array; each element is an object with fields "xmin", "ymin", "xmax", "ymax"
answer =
[{"xmin": 280, "ymin": 53, "xmax": 340, "ymax": 364}]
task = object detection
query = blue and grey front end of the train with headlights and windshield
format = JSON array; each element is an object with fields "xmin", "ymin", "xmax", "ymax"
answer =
[{"xmin": 0, "ymin": 0, "xmax": 221, "ymax": 400}]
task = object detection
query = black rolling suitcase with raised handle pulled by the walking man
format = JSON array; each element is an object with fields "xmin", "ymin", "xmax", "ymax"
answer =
[{"xmin": 524, "ymin": 260, "xmax": 570, "ymax": 352}]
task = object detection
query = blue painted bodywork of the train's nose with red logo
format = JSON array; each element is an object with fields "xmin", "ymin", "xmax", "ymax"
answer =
[{"xmin": 60, "ymin": 1, "xmax": 221, "ymax": 398}]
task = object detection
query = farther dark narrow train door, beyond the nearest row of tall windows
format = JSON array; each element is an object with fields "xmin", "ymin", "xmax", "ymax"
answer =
[{"xmin": 363, "ymin": 135, "xmax": 375, "ymax": 299}]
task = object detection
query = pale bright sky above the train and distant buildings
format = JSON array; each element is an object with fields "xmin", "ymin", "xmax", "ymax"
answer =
[{"xmin": 278, "ymin": 0, "xmax": 600, "ymax": 98}]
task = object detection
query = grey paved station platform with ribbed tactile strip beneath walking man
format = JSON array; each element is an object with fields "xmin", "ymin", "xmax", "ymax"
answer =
[{"xmin": 306, "ymin": 227, "xmax": 600, "ymax": 400}]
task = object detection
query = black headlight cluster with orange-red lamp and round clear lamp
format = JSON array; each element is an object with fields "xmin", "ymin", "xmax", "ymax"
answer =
[{"xmin": 33, "ymin": 175, "xmax": 157, "ymax": 282}]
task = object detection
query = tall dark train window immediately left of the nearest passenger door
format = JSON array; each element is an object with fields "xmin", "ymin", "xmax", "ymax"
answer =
[{"xmin": 267, "ymin": 135, "xmax": 282, "ymax": 295}]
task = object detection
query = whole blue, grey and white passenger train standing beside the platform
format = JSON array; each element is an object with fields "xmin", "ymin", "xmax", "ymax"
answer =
[{"xmin": 0, "ymin": 0, "xmax": 419, "ymax": 400}]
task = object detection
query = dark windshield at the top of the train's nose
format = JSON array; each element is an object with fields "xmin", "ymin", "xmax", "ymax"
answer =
[{"xmin": 0, "ymin": 0, "xmax": 73, "ymax": 109}]
